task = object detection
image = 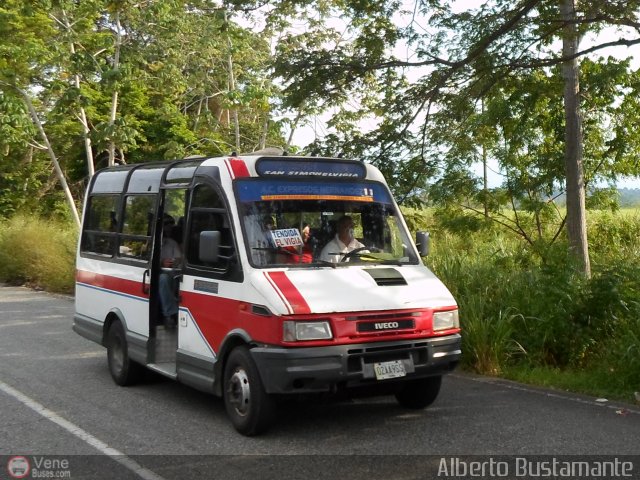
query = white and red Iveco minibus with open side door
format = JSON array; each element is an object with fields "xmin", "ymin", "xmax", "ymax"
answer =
[{"xmin": 73, "ymin": 154, "xmax": 461, "ymax": 435}]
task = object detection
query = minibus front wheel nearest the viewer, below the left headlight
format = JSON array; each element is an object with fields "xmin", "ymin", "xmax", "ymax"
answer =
[{"xmin": 223, "ymin": 346, "xmax": 275, "ymax": 436}]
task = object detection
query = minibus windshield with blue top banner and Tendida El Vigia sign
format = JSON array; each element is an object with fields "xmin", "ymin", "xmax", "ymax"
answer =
[{"xmin": 236, "ymin": 178, "xmax": 419, "ymax": 268}]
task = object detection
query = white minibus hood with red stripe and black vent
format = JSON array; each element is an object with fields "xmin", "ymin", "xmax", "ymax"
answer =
[{"xmin": 251, "ymin": 265, "xmax": 456, "ymax": 315}]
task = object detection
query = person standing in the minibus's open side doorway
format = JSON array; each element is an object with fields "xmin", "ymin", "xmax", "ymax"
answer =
[{"xmin": 158, "ymin": 214, "xmax": 182, "ymax": 329}]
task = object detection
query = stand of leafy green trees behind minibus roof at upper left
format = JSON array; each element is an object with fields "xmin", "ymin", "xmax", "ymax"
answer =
[{"xmin": 0, "ymin": 0, "xmax": 285, "ymax": 219}]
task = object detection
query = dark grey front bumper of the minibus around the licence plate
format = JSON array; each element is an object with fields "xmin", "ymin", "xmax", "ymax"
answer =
[{"xmin": 251, "ymin": 334, "xmax": 461, "ymax": 394}]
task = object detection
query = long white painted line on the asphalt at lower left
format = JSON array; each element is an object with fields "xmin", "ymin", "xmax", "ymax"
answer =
[{"xmin": 0, "ymin": 381, "xmax": 165, "ymax": 480}]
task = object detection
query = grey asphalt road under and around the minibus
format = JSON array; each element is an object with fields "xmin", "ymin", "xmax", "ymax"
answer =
[{"xmin": 0, "ymin": 286, "xmax": 640, "ymax": 480}]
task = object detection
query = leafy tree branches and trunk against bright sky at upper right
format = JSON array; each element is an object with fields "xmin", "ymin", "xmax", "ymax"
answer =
[{"xmin": 268, "ymin": 0, "xmax": 640, "ymax": 276}]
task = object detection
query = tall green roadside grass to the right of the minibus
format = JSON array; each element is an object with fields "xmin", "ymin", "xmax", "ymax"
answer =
[{"xmin": 427, "ymin": 212, "xmax": 640, "ymax": 400}]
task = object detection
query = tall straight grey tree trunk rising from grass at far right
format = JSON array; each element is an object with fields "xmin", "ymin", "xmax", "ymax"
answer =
[{"xmin": 560, "ymin": 0, "xmax": 591, "ymax": 277}]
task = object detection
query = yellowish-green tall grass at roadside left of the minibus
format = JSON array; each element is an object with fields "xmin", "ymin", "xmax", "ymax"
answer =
[{"xmin": 0, "ymin": 216, "xmax": 77, "ymax": 293}]
